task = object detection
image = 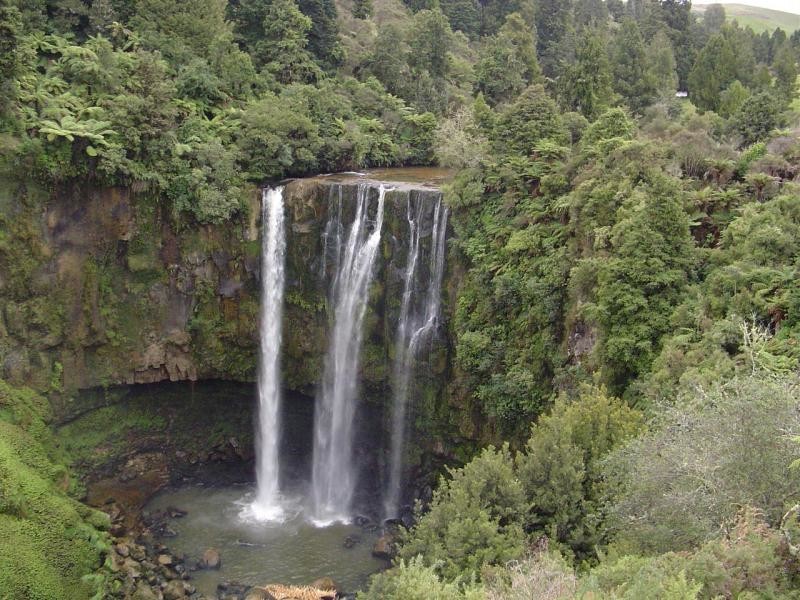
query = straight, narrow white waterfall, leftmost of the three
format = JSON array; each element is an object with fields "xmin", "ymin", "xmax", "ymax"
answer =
[{"xmin": 250, "ymin": 187, "xmax": 286, "ymax": 521}]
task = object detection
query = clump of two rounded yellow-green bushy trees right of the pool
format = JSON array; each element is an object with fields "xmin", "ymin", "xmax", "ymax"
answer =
[{"xmin": 400, "ymin": 387, "xmax": 642, "ymax": 580}]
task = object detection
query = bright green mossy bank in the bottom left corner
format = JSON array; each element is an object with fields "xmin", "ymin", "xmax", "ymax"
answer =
[{"xmin": 0, "ymin": 382, "xmax": 108, "ymax": 600}]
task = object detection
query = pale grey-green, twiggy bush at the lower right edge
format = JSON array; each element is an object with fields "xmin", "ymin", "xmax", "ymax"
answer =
[{"xmin": 609, "ymin": 373, "xmax": 800, "ymax": 553}]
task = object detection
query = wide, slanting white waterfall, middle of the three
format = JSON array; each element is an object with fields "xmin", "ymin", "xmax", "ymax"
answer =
[{"xmin": 311, "ymin": 183, "xmax": 386, "ymax": 524}]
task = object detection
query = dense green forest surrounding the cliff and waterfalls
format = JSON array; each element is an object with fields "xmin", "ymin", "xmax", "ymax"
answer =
[{"xmin": 0, "ymin": 0, "xmax": 800, "ymax": 600}]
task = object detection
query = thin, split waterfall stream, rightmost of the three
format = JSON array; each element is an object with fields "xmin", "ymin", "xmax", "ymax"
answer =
[{"xmin": 384, "ymin": 194, "xmax": 447, "ymax": 518}]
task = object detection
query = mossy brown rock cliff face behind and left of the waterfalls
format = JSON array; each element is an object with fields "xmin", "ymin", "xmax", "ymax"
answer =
[{"xmin": 0, "ymin": 171, "xmax": 470, "ymax": 452}]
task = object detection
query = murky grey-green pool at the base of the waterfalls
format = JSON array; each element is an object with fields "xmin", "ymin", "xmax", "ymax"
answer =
[{"xmin": 145, "ymin": 485, "xmax": 387, "ymax": 598}]
